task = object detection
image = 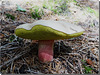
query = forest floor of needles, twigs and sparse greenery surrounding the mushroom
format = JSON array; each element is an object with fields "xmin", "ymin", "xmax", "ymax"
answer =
[{"xmin": 0, "ymin": 0, "xmax": 99, "ymax": 74}]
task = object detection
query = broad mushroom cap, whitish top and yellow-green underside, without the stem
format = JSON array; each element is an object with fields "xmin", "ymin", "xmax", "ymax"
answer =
[{"xmin": 15, "ymin": 20, "xmax": 84, "ymax": 40}]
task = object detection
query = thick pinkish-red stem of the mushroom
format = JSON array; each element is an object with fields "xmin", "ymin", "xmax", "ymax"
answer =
[{"xmin": 38, "ymin": 40, "xmax": 54, "ymax": 62}]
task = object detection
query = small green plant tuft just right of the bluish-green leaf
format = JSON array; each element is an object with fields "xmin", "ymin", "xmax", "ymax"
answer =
[{"xmin": 30, "ymin": 6, "xmax": 44, "ymax": 19}]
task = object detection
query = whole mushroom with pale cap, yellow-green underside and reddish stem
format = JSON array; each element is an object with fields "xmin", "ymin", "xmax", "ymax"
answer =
[{"xmin": 15, "ymin": 20, "xmax": 84, "ymax": 62}]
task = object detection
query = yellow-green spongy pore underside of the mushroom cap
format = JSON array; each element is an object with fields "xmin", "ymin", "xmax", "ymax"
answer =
[{"xmin": 15, "ymin": 25, "xmax": 83, "ymax": 40}]
